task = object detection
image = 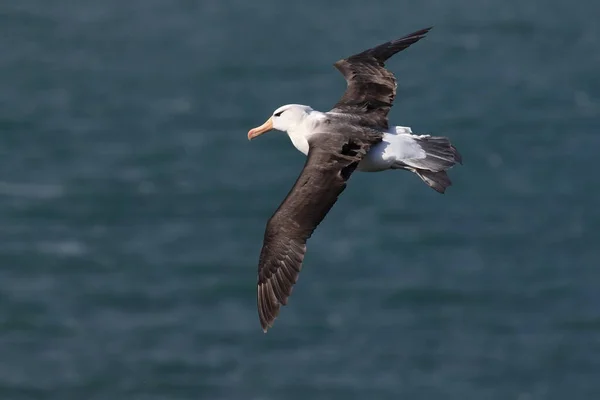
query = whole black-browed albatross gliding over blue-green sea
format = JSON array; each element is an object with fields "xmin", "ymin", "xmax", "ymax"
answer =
[{"xmin": 248, "ymin": 27, "xmax": 462, "ymax": 333}]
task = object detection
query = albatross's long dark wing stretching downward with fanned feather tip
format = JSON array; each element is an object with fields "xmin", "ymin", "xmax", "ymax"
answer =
[{"xmin": 258, "ymin": 128, "xmax": 381, "ymax": 332}]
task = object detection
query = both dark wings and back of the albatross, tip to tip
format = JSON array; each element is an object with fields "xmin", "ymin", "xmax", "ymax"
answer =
[{"xmin": 257, "ymin": 28, "xmax": 431, "ymax": 332}]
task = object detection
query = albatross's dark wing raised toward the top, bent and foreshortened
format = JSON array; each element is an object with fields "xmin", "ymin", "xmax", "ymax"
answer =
[{"xmin": 332, "ymin": 28, "xmax": 431, "ymax": 128}]
